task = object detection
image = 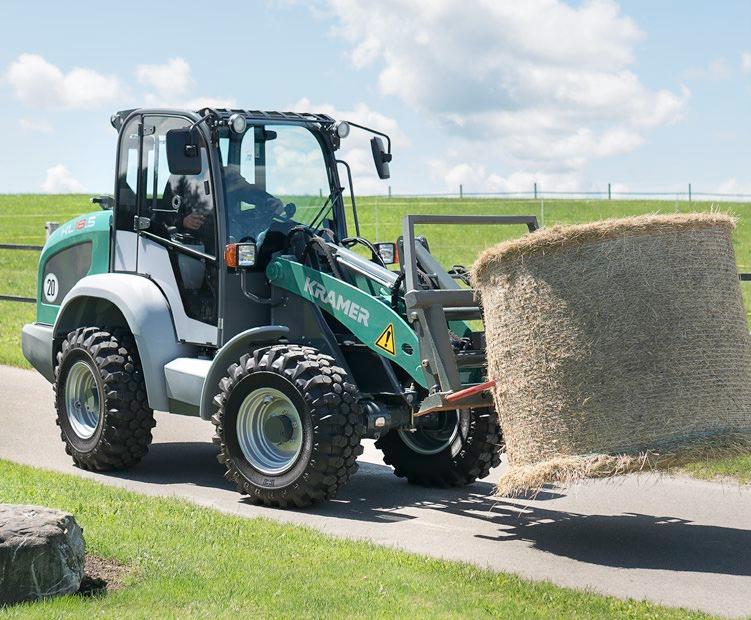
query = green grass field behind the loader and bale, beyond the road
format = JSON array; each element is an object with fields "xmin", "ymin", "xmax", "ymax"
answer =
[{"xmin": 0, "ymin": 195, "xmax": 751, "ymax": 477}]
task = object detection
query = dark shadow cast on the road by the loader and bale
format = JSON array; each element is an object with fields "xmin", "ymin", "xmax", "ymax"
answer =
[{"xmin": 108, "ymin": 442, "xmax": 751, "ymax": 576}]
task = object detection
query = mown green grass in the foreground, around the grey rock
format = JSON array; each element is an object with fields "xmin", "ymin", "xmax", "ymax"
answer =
[{"xmin": 0, "ymin": 461, "xmax": 707, "ymax": 619}]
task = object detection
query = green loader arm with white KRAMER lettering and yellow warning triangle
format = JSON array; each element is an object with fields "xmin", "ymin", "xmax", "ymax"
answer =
[{"xmin": 266, "ymin": 257, "xmax": 427, "ymax": 387}]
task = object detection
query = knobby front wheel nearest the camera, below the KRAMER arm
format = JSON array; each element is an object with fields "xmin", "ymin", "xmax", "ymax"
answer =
[{"xmin": 212, "ymin": 345, "xmax": 365, "ymax": 508}]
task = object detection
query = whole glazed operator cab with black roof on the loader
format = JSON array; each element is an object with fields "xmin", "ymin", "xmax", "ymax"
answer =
[{"xmin": 111, "ymin": 110, "xmax": 346, "ymax": 347}]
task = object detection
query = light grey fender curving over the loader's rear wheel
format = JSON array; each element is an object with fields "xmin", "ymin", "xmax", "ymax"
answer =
[{"xmin": 53, "ymin": 273, "xmax": 192, "ymax": 411}]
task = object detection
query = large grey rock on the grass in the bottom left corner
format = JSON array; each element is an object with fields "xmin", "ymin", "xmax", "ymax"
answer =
[{"xmin": 0, "ymin": 504, "xmax": 85, "ymax": 605}]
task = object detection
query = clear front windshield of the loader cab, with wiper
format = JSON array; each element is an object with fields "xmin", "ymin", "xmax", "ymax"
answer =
[{"xmin": 219, "ymin": 124, "xmax": 333, "ymax": 242}]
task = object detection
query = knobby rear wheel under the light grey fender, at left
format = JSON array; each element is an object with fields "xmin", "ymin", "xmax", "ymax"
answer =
[{"xmin": 54, "ymin": 327, "xmax": 156, "ymax": 471}]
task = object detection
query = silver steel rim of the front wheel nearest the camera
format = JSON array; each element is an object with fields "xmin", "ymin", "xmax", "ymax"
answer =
[{"xmin": 237, "ymin": 387, "xmax": 303, "ymax": 475}]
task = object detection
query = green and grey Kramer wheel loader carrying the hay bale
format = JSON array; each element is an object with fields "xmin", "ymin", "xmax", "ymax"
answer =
[{"xmin": 22, "ymin": 108, "xmax": 537, "ymax": 508}]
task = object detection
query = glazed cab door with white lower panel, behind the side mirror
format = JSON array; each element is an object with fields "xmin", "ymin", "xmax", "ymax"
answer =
[{"xmin": 115, "ymin": 114, "xmax": 219, "ymax": 346}]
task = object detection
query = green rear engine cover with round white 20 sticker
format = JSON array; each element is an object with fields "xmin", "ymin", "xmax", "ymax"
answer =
[{"xmin": 37, "ymin": 211, "xmax": 112, "ymax": 325}]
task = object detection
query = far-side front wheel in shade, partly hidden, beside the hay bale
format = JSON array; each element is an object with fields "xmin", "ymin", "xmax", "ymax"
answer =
[{"xmin": 375, "ymin": 409, "xmax": 503, "ymax": 487}]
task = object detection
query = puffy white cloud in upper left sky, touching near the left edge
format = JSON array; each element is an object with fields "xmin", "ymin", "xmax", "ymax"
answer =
[{"xmin": 5, "ymin": 54, "xmax": 121, "ymax": 109}]
